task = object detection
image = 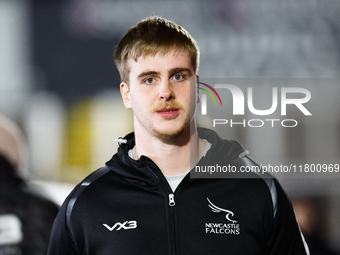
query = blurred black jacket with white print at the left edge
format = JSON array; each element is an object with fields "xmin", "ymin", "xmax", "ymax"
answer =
[{"xmin": 0, "ymin": 155, "xmax": 59, "ymax": 255}]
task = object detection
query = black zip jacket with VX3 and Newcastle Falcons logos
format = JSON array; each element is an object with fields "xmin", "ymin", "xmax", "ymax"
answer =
[{"xmin": 48, "ymin": 129, "xmax": 306, "ymax": 255}]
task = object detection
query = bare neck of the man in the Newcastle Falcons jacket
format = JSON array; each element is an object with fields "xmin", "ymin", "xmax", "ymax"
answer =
[{"xmin": 135, "ymin": 125, "xmax": 205, "ymax": 175}]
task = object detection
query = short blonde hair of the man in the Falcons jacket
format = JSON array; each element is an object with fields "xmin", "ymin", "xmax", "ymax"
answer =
[{"xmin": 114, "ymin": 16, "xmax": 200, "ymax": 84}]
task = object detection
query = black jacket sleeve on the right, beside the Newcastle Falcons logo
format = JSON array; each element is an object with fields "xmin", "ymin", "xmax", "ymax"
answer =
[{"xmin": 267, "ymin": 179, "xmax": 309, "ymax": 255}]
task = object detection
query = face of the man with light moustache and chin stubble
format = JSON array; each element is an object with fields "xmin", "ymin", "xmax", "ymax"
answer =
[{"xmin": 121, "ymin": 50, "xmax": 196, "ymax": 139}]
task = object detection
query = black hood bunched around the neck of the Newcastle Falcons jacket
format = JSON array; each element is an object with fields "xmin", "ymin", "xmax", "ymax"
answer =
[{"xmin": 106, "ymin": 128, "xmax": 247, "ymax": 185}]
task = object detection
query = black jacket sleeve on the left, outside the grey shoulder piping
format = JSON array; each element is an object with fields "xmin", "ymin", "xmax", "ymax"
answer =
[{"xmin": 47, "ymin": 190, "xmax": 79, "ymax": 255}]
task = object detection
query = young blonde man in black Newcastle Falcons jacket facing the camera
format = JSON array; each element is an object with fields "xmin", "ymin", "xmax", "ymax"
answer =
[{"xmin": 48, "ymin": 17, "xmax": 307, "ymax": 255}]
